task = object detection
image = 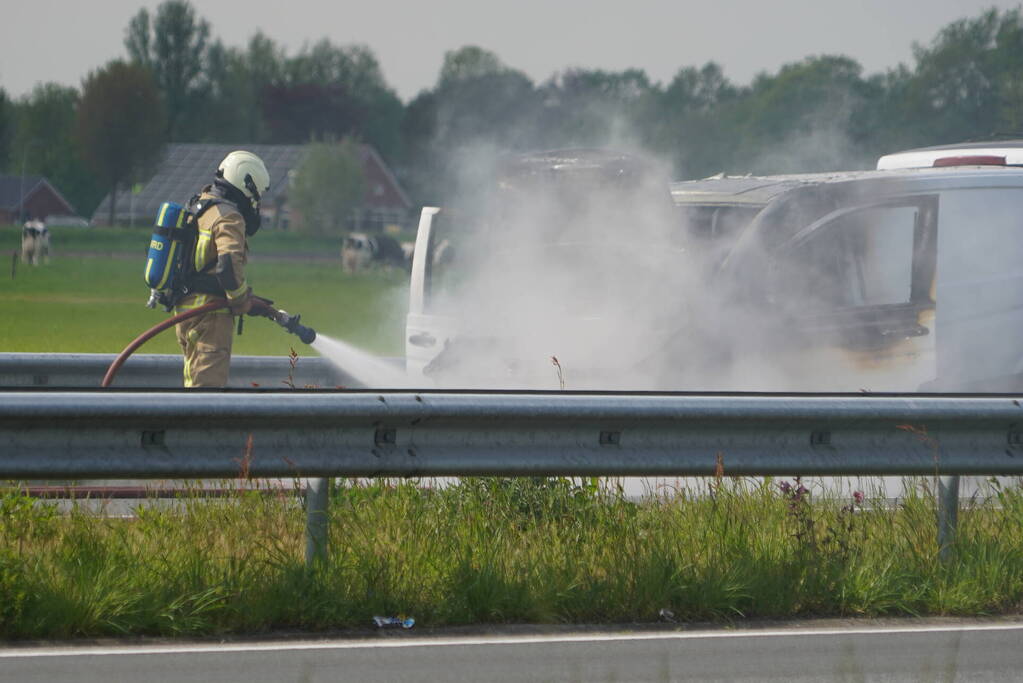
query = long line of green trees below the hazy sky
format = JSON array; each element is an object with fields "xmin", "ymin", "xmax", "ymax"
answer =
[{"xmin": 0, "ymin": 0, "xmax": 1023, "ymax": 221}]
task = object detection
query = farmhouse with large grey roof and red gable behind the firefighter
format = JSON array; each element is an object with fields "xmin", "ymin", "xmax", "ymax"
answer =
[{"xmin": 93, "ymin": 143, "xmax": 412, "ymax": 230}]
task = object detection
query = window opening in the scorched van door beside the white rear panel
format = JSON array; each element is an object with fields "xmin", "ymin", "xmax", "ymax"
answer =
[{"xmin": 790, "ymin": 204, "xmax": 922, "ymax": 310}]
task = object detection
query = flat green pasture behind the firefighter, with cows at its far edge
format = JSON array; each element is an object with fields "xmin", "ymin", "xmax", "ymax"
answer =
[{"xmin": 0, "ymin": 226, "xmax": 408, "ymax": 356}]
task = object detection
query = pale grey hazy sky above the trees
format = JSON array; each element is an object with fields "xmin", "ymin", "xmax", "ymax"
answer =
[{"xmin": 0, "ymin": 0, "xmax": 1020, "ymax": 100}]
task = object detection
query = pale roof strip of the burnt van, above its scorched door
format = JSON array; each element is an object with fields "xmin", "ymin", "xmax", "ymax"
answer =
[{"xmin": 671, "ymin": 165, "xmax": 1023, "ymax": 207}]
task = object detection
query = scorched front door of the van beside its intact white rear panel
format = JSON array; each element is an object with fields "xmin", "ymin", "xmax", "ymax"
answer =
[{"xmin": 772, "ymin": 195, "xmax": 938, "ymax": 392}]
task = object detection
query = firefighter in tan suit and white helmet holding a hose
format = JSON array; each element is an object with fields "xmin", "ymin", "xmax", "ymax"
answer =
[{"xmin": 174, "ymin": 151, "xmax": 270, "ymax": 388}]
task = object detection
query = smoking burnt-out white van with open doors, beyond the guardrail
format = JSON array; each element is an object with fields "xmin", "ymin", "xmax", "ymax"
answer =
[{"xmin": 406, "ymin": 160, "xmax": 1023, "ymax": 392}]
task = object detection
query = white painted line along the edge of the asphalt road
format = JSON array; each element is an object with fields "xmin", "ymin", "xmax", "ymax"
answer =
[{"xmin": 0, "ymin": 624, "xmax": 1023, "ymax": 659}]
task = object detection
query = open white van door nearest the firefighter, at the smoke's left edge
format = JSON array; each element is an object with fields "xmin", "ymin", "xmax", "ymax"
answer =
[{"xmin": 405, "ymin": 207, "xmax": 455, "ymax": 386}]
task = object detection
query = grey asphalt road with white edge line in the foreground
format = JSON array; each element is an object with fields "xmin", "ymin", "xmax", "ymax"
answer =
[{"xmin": 0, "ymin": 621, "xmax": 1023, "ymax": 683}]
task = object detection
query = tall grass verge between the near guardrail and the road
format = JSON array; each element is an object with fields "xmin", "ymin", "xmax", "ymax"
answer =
[{"xmin": 0, "ymin": 479, "xmax": 1023, "ymax": 638}]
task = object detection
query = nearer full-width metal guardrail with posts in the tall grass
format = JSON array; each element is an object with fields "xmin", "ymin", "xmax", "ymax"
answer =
[{"xmin": 0, "ymin": 390, "xmax": 1023, "ymax": 560}]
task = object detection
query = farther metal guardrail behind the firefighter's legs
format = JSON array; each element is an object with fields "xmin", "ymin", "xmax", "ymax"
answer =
[{"xmin": 0, "ymin": 353, "xmax": 390, "ymax": 389}]
